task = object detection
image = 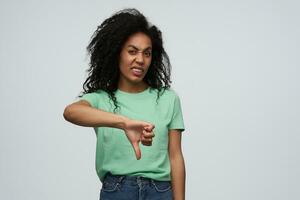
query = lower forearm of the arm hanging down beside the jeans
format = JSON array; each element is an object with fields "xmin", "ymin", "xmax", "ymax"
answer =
[{"xmin": 170, "ymin": 154, "xmax": 185, "ymax": 200}]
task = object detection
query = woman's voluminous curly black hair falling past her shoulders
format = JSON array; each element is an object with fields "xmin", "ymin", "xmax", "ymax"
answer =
[{"xmin": 79, "ymin": 8, "xmax": 171, "ymax": 111}]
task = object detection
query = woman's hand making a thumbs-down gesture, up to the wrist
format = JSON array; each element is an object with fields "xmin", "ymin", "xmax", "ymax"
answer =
[{"xmin": 124, "ymin": 119, "xmax": 154, "ymax": 160}]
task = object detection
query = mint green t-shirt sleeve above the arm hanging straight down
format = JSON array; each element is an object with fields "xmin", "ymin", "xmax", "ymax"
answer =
[{"xmin": 168, "ymin": 95, "xmax": 185, "ymax": 131}]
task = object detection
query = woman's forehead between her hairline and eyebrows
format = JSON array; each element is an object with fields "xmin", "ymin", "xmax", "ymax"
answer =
[{"xmin": 124, "ymin": 32, "xmax": 152, "ymax": 49}]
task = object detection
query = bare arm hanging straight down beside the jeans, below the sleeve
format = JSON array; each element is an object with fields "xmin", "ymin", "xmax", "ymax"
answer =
[{"xmin": 169, "ymin": 130, "xmax": 185, "ymax": 200}]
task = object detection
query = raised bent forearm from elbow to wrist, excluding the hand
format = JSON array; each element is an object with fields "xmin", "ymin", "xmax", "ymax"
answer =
[{"xmin": 64, "ymin": 105, "xmax": 127, "ymax": 129}]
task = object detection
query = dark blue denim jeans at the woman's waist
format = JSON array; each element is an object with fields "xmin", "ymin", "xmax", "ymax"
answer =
[{"xmin": 100, "ymin": 173, "xmax": 173, "ymax": 200}]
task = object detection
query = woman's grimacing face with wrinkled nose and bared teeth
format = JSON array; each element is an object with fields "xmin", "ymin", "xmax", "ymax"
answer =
[{"xmin": 119, "ymin": 32, "xmax": 152, "ymax": 84}]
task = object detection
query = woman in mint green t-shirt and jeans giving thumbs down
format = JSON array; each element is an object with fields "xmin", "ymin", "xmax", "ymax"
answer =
[{"xmin": 64, "ymin": 9, "xmax": 185, "ymax": 200}]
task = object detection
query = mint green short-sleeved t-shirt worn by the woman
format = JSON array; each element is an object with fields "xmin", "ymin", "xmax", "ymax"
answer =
[{"xmin": 80, "ymin": 87, "xmax": 184, "ymax": 181}]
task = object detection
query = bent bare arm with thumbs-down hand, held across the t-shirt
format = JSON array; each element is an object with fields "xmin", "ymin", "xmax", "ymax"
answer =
[{"xmin": 63, "ymin": 100, "xmax": 154, "ymax": 160}]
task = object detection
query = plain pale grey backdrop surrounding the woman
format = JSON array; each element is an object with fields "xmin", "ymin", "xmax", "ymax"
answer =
[{"xmin": 0, "ymin": 0, "xmax": 300, "ymax": 200}]
